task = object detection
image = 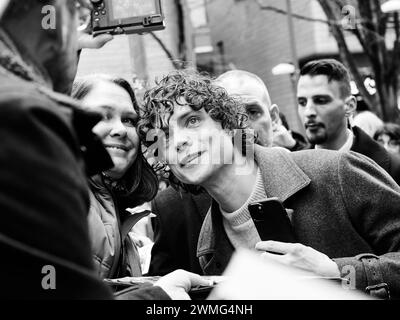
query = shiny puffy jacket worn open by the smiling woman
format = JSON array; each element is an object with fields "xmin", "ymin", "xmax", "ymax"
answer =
[{"xmin": 88, "ymin": 175, "xmax": 150, "ymax": 279}]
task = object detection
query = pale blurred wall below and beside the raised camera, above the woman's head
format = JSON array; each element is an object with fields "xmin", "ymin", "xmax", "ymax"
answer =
[{"xmin": 77, "ymin": 0, "xmax": 196, "ymax": 96}]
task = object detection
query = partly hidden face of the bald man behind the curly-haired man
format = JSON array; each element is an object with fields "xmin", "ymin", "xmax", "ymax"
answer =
[{"xmin": 217, "ymin": 76, "xmax": 279, "ymax": 147}]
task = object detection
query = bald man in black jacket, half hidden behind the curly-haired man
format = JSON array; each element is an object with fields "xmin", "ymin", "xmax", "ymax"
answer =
[{"xmin": 149, "ymin": 70, "xmax": 283, "ymax": 275}]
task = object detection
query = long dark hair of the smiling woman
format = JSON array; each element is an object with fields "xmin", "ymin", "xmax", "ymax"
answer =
[{"xmin": 71, "ymin": 74, "xmax": 158, "ymax": 206}]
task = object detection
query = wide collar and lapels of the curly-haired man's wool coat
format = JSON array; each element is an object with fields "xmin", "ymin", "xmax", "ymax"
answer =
[{"xmin": 197, "ymin": 146, "xmax": 311, "ymax": 267}]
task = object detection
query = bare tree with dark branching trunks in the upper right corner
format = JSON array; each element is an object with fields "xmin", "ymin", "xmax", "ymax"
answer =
[{"xmin": 257, "ymin": 0, "xmax": 400, "ymax": 121}]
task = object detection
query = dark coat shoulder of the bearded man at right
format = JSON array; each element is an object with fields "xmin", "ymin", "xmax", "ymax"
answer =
[{"xmin": 351, "ymin": 126, "xmax": 400, "ymax": 185}]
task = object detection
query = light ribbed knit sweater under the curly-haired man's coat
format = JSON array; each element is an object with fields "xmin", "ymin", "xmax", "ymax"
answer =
[{"xmin": 220, "ymin": 169, "xmax": 267, "ymax": 250}]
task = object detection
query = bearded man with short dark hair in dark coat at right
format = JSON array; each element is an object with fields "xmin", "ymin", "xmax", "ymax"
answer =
[{"xmin": 297, "ymin": 59, "xmax": 400, "ymax": 184}]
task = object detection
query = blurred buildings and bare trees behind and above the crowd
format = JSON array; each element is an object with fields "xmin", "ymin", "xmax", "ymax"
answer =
[{"xmin": 78, "ymin": 0, "xmax": 400, "ymax": 132}]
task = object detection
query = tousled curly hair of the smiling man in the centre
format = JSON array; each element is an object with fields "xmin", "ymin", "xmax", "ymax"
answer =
[{"xmin": 138, "ymin": 69, "xmax": 250, "ymax": 193}]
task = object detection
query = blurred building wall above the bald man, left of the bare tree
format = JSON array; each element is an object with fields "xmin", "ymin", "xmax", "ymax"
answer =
[{"xmin": 206, "ymin": 0, "xmax": 370, "ymax": 132}]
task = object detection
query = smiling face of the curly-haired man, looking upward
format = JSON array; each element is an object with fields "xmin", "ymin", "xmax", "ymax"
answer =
[{"xmin": 161, "ymin": 104, "xmax": 233, "ymax": 187}]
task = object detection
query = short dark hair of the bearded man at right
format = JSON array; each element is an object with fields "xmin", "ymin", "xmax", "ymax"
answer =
[{"xmin": 300, "ymin": 59, "xmax": 351, "ymax": 98}]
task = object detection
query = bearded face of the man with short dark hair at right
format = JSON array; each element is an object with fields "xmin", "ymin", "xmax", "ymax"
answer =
[{"xmin": 297, "ymin": 75, "xmax": 348, "ymax": 144}]
